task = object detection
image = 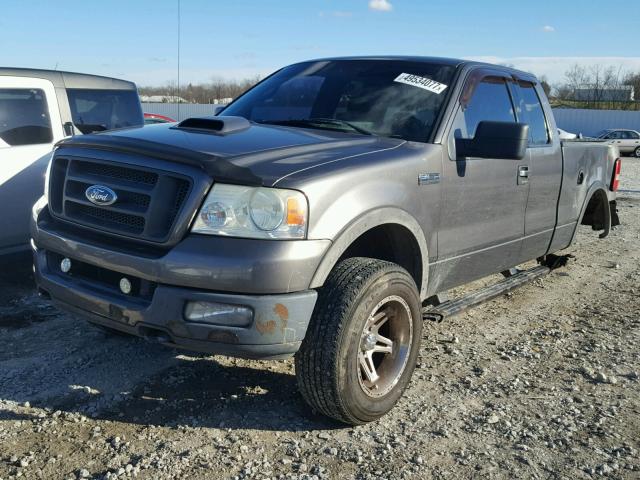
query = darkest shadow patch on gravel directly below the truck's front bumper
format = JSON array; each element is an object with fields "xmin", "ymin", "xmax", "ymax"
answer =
[{"xmin": 103, "ymin": 357, "xmax": 339, "ymax": 431}]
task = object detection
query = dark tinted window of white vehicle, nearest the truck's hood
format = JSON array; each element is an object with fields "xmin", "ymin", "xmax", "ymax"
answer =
[{"xmin": 67, "ymin": 88, "xmax": 144, "ymax": 134}]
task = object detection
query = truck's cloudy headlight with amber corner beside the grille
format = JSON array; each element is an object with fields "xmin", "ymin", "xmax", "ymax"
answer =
[{"xmin": 191, "ymin": 183, "xmax": 308, "ymax": 239}]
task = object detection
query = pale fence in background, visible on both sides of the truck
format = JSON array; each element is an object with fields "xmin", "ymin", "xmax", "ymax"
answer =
[{"xmin": 142, "ymin": 103, "xmax": 640, "ymax": 136}]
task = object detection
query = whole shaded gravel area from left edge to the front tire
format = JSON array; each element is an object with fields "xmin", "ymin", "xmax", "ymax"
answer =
[{"xmin": 0, "ymin": 255, "xmax": 341, "ymax": 431}]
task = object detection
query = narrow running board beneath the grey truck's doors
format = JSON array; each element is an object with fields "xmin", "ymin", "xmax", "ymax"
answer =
[{"xmin": 422, "ymin": 265, "xmax": 551, "ymax": 322}]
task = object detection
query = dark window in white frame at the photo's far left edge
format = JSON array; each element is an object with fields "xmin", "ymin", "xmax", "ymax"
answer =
[{"xmin": 0, "ymin": 88, "xmax": 53, "ymax": 146}]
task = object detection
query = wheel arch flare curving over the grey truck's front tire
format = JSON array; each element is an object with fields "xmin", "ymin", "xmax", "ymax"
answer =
[{"xmin": 310, "ymin": 207, "xmax": 429, "ymax": 298}]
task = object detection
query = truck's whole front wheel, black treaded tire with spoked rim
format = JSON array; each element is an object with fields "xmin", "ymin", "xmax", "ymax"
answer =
[{"xmin": 296, "ymin": 257, "xmax": 422, "ymax": 425}]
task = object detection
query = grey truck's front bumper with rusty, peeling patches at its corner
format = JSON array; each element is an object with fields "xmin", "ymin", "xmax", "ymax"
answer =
[{"xmin": 31, "ymin": 200, "xmax": 329, "ymax": 358}]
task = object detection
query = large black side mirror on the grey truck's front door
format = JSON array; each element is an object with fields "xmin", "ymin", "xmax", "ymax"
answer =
[{"xmin": 456, "ymin": 121, "xmax": 529, "ymax": 160}]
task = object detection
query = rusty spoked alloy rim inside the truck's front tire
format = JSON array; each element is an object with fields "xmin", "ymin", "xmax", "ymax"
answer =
[{"xmin": 357, "ymin": 295, "xmax": 413, "ymax": 397}]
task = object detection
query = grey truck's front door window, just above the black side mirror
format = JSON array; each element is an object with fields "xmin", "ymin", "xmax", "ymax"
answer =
[{"xmin": 454, "ymin": 77, "xmax": 516, "ymax": 138}]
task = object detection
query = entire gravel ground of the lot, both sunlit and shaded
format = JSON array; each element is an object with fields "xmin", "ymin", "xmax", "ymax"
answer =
[{"xmin": 0, "ymin": 159, "xmax": 640, "ymax": 480}]
